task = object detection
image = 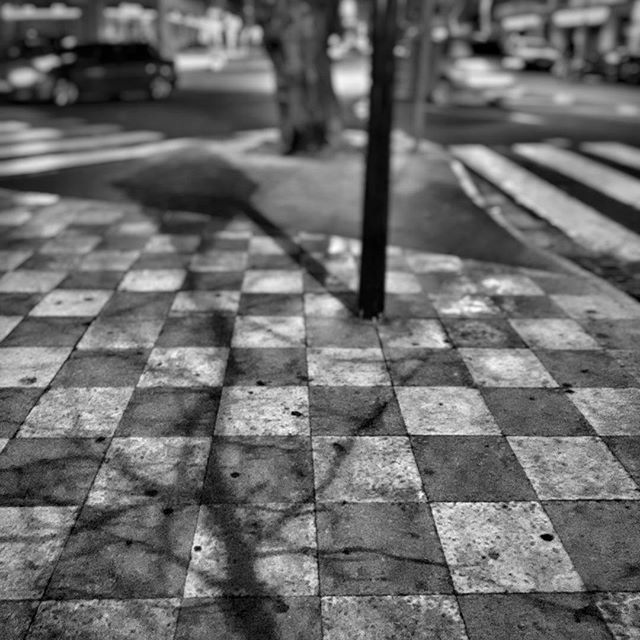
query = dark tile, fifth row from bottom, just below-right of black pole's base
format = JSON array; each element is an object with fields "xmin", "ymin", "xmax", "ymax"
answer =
[{"xmin": 385, "ymin": 348, "xmax": 473, "ymax": 387}]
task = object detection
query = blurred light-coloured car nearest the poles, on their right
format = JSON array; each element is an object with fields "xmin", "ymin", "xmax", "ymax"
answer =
[{"xmin": 430, "ymin": 38, "xmax": 519, "ymax": 106}]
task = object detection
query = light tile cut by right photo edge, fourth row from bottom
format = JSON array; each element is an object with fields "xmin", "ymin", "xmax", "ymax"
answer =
[{"xmin": 568, "ymin": 388, "xmax": 640, "ymax": 436}]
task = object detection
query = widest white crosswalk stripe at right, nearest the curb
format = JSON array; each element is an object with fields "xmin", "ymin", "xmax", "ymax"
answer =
[{"xmin": 451, "ymin": 145, "xmax": 640, "ymax": 261}]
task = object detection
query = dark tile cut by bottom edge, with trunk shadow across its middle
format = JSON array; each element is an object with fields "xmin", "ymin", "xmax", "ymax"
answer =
[{"xmin": 175, "ymin": 596, "xmax": 322, "ymax": 640}]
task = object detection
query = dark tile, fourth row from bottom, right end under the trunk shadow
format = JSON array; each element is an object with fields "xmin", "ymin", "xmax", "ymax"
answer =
[{"xmin": 116, "ymin": 387, "xmax": 220, "ymax": 437}]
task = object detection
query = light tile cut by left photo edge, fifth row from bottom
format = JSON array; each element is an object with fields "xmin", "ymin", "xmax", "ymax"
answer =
[{"xmin": 0, "ymin": 347, "xmax": 71, "ymax": 387}]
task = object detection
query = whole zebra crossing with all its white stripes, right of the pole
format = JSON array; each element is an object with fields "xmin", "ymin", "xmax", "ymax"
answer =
[{"xmin": 450, "ymin": 142, "xmax": 640, "ymax": 262}]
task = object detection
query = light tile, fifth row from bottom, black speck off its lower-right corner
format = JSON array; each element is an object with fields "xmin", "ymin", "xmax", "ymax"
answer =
[{"xmin": 460, "ymin": 349, "xmax": 558, "ymax": 387}]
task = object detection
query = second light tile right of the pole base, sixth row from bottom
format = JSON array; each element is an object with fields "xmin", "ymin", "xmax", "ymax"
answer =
[{"xmin": 509, "ymin": 318, "xmax": 600, "ymax": 349}]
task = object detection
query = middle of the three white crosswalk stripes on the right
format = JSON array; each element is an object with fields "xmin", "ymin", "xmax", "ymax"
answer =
[{"xmin": 513, "ymin": 144, "xmax": 640, "ymax": 209}]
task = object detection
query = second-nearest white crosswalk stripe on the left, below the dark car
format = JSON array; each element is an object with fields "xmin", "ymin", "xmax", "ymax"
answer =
[{"xmin": 0, "ymin": 131, "xmax": 163, "ymax": 159}]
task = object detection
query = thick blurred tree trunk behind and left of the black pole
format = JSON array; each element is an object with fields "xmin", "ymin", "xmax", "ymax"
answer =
[{"xmin": 256, "ymin": 0, "xmax": 341, "ymax": 154}]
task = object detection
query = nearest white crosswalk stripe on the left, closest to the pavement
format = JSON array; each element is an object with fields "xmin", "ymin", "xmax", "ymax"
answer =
[{"xmin": 0, "ymin": 138, "xmax": 186, "ymax": 177}]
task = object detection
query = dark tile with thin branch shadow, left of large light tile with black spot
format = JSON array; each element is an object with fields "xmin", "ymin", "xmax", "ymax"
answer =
[{"xmin": 317, "ymin": 503, "xmax": 452, "ymax": 596}]
